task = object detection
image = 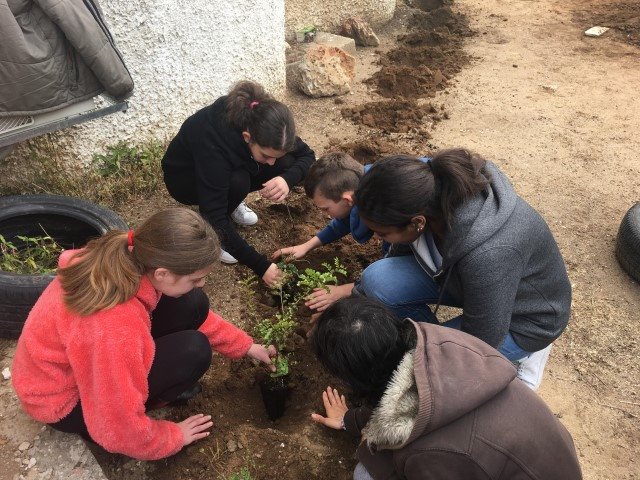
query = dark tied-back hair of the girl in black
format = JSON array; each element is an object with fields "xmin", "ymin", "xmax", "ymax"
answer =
[{"xmin": 225, "ymin": 80, "xmax": 296, "ymax": 152}]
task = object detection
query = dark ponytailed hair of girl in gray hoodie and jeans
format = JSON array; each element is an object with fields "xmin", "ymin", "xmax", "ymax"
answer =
[{"xmin": 355, "ymin": 148, "xmax": 490, "ymax": 228}]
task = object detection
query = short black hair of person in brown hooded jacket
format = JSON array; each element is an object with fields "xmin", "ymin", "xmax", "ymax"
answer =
[{"xmin": 309, "ymin": 297, "xmax": 417, "ymax": 407}]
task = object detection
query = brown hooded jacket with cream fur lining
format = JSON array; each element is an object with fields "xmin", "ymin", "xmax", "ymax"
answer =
[{"xmin": 344, "ymin": 323, "xmax": 582, "ymax": 480}]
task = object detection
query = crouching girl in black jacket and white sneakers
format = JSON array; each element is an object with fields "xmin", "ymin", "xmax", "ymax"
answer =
[{"xmin": 162, "ymin": 81, "xmax": 315, "ymax": 285}]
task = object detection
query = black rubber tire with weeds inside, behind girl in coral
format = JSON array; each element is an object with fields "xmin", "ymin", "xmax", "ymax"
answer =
[{"xmin": 0, "ymin": 195, "xmax": 128, "ymax": 338}]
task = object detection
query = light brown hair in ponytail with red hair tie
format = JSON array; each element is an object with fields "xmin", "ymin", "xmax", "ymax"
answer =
[{"xmin": 58, "ymin": 208, "xmax": 220, "ymax": 316}]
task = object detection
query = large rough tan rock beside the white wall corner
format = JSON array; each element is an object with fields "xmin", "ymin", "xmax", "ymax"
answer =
[{"xmin": 297, "ymin": 45, "xmax": 356, "ymax": 97}]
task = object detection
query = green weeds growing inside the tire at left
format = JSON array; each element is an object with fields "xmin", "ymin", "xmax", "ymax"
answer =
[{"xmin": 0, "ymin": 227, "xmax": 62, "ymax": 275}]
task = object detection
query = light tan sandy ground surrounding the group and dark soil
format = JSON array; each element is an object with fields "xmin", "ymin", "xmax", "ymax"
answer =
[{"xmin": 0, "ymin": 0, "xmax": 640, "ymax": 480}]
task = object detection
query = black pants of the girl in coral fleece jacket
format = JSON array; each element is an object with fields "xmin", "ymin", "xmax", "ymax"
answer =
[{"xmin": 50, "ymin": 288, "xmax": 212, "ymax": 441}]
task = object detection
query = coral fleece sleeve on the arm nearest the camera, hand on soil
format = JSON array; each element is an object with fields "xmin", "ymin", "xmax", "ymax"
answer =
[{"xmin": 68, "ymin": 310, "xmax": 183, "ymax": 460}]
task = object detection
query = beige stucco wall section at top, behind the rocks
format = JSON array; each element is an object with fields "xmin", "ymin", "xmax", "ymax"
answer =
[{"xmin": 285, "ymin": 0, "xmax": 396, "ymax": 40}]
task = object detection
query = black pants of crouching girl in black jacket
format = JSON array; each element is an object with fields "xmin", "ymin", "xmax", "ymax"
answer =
[{"xmin": 164, "ymin": 154, "xmax": 295, "ymax": 215}]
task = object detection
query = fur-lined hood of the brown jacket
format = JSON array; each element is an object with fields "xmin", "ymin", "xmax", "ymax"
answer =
[{"xmin": 362, "ymin": 320, "xmax": 516, "ymax": 449}]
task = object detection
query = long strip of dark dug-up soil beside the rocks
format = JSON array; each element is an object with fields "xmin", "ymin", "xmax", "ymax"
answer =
[{"xmin": 342, "ymin": 0, "xmax": 471, "ymax": 141}]
